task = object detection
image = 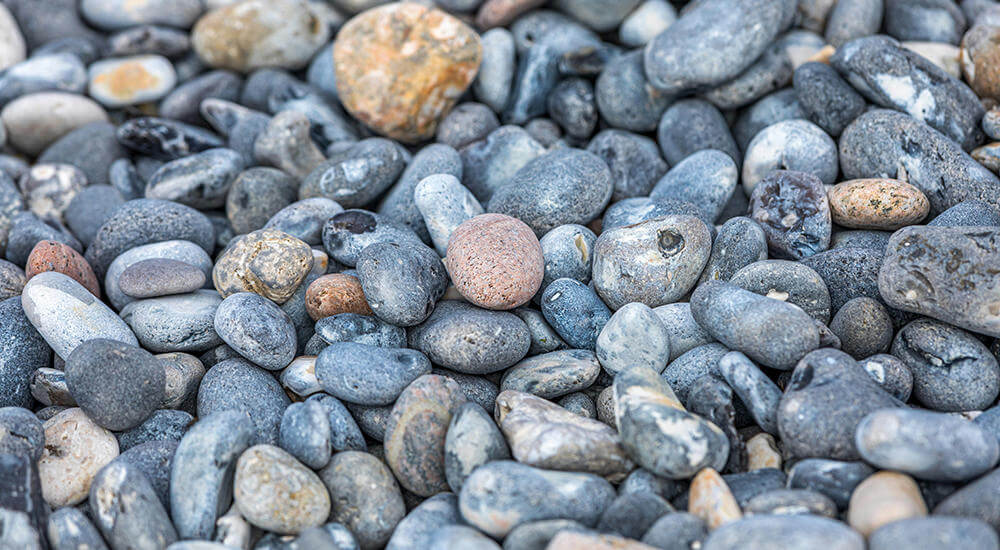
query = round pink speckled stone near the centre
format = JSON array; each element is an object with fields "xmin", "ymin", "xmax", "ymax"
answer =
[{"xmin": 444, "ymin": 214, "xmax": 545, "ymax": 309}]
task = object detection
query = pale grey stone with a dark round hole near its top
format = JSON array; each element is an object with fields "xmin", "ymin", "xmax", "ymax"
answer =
[{"xmin": 593, "ymin": 216, "xmax": 712, "ymax": 309}]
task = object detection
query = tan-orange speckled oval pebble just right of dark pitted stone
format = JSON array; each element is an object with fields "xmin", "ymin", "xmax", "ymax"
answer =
[{"xmin": 827, "ymin": 178, "xmax": 930, "ymax": 231}]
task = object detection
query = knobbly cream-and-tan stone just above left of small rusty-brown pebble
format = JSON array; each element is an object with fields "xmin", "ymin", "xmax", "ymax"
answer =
[{"xmin": 212, "ymin": 229, "xmax": 313, "ymax": 306}]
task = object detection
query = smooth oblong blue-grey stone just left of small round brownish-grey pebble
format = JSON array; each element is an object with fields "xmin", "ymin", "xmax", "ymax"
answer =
[{"xmin": 691, "ymin": 281, "xmax": 819, "ymax": 370}]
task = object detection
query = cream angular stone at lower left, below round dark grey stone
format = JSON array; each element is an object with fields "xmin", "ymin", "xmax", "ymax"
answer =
[{"xmin": 38, "ymin": 408, "xmax": 118, "ymax": 508}]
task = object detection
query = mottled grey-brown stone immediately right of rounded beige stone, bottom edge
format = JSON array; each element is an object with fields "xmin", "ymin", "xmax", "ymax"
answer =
[{"xmin": 320, "ymin": 451, "xmax": 406, "ymax": 550}]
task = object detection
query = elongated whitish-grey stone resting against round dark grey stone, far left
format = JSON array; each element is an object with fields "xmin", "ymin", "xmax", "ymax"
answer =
[{"xmin": 21, "ymin": 271, "xmax": 139, "ymax": 357}]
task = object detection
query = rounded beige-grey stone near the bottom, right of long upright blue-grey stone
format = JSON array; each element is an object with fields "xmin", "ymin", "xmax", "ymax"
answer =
[{"xmin": 233, "ymin": 445, "xmax": 330, "ymax": 534}]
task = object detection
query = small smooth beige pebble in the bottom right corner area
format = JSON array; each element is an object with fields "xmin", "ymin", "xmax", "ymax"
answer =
[{"xmin": 847, "ymin": 472, "xmax": 927, "ymax": 537}]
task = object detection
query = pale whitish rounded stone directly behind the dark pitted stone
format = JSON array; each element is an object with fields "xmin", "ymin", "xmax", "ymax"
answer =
[{"xmin": 742, "ymin": 119, "xmax": 838, "ymax": 197}]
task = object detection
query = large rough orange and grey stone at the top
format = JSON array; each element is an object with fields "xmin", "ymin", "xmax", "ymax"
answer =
[{"xmin": 333, "ymin": 2, "xmax": 482, "ymax": 143}]
